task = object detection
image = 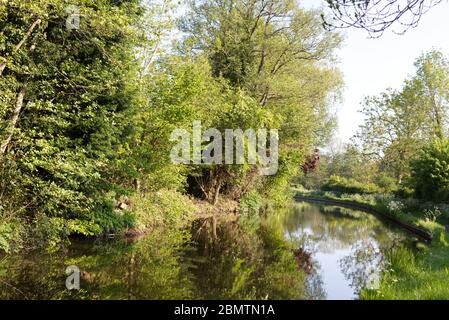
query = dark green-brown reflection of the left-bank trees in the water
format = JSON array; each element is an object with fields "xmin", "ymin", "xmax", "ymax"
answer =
[{"xmin": 0, "ymin": 212, "xmax": 304, "ymax": 299}]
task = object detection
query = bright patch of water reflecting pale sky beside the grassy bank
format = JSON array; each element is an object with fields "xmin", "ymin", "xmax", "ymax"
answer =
[{"xmin": 284, "ymin": 203, "xmax": 406, "ymax": 299}]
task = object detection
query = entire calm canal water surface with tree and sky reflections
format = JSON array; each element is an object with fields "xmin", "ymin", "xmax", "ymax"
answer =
[{"xmin": 0, "ymin": 203, "xmax": 411, "ymax": 299}]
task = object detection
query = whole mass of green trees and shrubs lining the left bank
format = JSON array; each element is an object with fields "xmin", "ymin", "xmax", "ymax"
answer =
[{"xmin": 0, "ymin": 0, "xmax": 342, "ymax": 251}]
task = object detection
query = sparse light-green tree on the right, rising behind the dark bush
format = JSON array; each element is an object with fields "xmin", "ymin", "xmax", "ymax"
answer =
[{"xmin": 356, "ymin": 51, "xmax": 449, "ymax": 183}]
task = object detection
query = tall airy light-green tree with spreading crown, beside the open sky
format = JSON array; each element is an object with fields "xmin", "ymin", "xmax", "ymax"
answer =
[{"xmin": 181, "ymin": 0, "xmax": 341, "ymax": 202}]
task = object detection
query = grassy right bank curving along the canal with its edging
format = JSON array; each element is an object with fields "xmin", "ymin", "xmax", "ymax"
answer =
[{"xmin": 296, "ymin": 190, "xmax": 449, "ymax": 300}]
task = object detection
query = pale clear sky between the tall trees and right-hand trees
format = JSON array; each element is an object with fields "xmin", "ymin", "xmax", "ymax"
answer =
[{"xmin": 301, "ymin": 0, "xmax": 449, "ymax": 142}]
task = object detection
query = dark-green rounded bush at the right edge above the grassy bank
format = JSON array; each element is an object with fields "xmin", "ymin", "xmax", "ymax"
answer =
[{"xmin": 410, "ymin": 139, "xmax": 449, "ymax": 201}]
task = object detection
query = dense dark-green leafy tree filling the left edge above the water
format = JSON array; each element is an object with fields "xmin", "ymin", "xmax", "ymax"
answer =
[{"xmin": 0, "ymin": 0, "xmax": 144, "ymax": 250}]
